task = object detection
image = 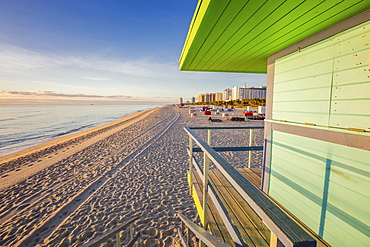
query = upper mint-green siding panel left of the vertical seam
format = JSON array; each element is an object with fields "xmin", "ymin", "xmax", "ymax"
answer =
[{"xmin": 272, "ymin": 37, "xmax": 333, "ymax": 126}]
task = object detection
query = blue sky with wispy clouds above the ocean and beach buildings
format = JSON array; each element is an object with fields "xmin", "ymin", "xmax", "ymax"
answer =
[{"xmin": 0, "ymin": 0, "xmax": 266, "ymax": 104}]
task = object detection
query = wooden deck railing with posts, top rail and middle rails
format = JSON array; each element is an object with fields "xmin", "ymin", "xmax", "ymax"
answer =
[{"xmin": 185, "ymin": 127, "xmax": 316, "ymax": 247}]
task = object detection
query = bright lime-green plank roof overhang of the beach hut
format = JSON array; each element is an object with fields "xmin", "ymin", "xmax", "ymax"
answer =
[{"xmin": 180, "ymin": 0, "xmax": 370, "ymax": 73}]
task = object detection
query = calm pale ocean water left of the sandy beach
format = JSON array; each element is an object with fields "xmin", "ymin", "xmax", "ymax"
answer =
[{"xmin": 0, "ymin": 105, "xmax": 159, "ymax": 156}]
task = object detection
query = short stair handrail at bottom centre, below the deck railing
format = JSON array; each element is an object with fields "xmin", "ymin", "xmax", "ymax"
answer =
[{"xmin": 177, "ymin": 213, "xmax": 230, "ymax": 247}]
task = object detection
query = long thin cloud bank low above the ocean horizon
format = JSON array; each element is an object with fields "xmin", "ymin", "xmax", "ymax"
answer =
[{"xmin": 0, "ymin": 90, "xmax": 133, "ymax": 99}]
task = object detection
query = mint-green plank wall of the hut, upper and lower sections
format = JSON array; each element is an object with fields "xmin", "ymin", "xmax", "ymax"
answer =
[{"xmin": 268, "ymin": 21, "xmax": 370, "ymax": 246}]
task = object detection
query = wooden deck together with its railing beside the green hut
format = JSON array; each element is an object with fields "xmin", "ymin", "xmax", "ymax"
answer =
[{"xmin": 184, "ymin": 127, "xmax": 330, "ymax": 247}]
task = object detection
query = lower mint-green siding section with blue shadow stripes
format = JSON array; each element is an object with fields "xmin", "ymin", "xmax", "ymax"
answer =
[{"xmin": 269, "ymin": 131, "xmax": 370, "ymax": 246}]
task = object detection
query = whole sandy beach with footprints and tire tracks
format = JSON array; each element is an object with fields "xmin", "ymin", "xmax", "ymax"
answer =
[{"xmin": 0, "ymin": 107, "xmax": 263, "ymax": 246}]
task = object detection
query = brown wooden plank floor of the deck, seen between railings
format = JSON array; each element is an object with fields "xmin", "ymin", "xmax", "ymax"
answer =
[{"xmin": 189, "ymin": 168, "xmax": 271, "ymax": 246}]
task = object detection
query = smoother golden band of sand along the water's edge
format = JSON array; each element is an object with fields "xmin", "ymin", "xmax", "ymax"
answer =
[{"xmin": 0, "ymin": 108, "xmax": 158, "ymax": 190}]
